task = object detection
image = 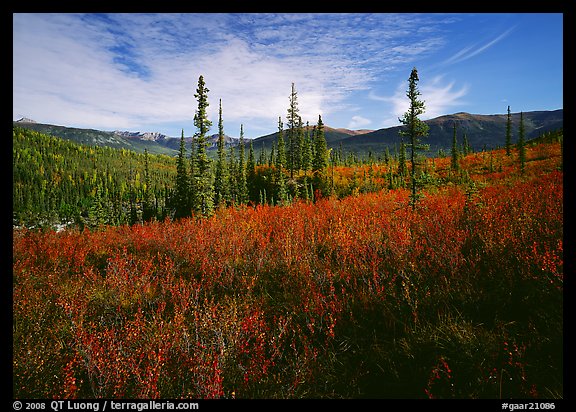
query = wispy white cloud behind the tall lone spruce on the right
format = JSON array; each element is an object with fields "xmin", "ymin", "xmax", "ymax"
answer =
[{"xmin": 369, "ymin": 75, "xmax": 469, "ymax": 127}]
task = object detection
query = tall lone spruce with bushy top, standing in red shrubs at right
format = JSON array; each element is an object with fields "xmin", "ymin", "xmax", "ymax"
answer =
[{"xmin": 398, "ymin": 67, "xmax": 428, "ymax": 209}]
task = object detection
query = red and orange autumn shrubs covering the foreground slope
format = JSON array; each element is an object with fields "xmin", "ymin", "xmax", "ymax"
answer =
[{"xmin": 13, "ymin": 140, "xmax": 564, "ymax": 398}]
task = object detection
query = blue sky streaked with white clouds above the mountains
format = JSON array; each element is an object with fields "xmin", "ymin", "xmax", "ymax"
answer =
[{"xmin": 12, "ymin": 13, "xmax": 563, "ymax": 138}]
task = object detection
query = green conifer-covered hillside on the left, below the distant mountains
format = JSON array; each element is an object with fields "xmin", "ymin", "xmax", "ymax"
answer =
[{"xmin": 12, "ymin": 127, "xmax": 176, "ymax": 227}]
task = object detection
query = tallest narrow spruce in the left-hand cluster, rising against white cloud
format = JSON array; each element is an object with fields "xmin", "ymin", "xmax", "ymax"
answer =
[{"xmin": 193, "ymin": 76, "xmax": 214, "ymax": 216}]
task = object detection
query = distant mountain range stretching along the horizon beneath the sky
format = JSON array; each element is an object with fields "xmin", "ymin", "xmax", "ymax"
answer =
[{"xmin": 13, "ymin": 109, "xmax": 564, "ymax": 155}]
